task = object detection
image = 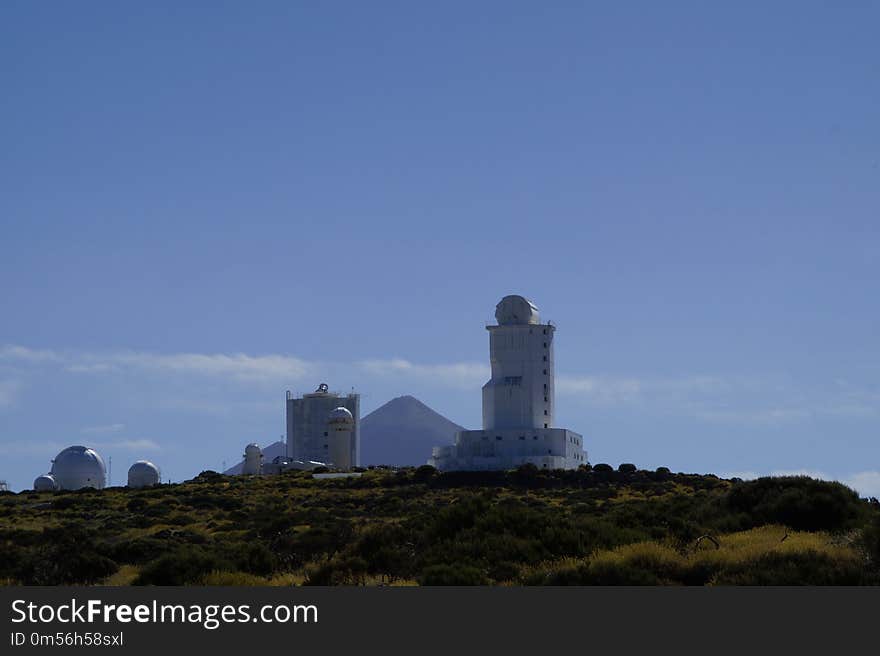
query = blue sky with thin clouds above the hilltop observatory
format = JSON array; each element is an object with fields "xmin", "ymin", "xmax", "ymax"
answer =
[{"xmin": 0, "ymin": 2, "xmax": 880, "ymax": 495}]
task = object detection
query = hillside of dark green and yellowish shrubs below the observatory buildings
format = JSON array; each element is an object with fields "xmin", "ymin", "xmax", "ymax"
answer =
[{"xmin": 0, "ymin": 465, "xmax": 880, "ymax": 585}]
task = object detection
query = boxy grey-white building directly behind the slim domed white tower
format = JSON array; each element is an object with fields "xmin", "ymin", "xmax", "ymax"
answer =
[{"xmin": 287, "ymin": 383, "xmax": 361, "ymax": 469}]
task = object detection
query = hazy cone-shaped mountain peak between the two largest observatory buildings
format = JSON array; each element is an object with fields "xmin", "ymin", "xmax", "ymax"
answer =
[{"xmin": 361, "ymin": 396, "xmax": 464, "ymax": 467}]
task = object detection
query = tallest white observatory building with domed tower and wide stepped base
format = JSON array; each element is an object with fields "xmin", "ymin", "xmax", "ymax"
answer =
[{"xmin": 428, "ymin": 296, "xmax": 587, "ymax": 471}]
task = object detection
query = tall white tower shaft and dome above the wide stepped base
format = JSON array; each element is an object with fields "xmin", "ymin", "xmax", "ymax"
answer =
[{"xmin": 483, "ymin": 296, "xmax": 555, "ymax": 430}]
